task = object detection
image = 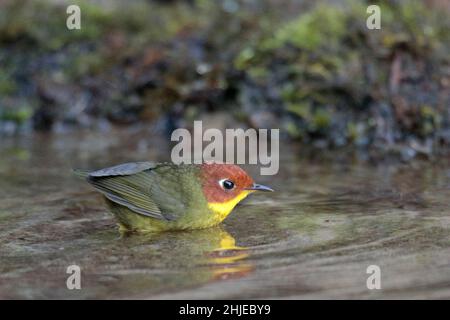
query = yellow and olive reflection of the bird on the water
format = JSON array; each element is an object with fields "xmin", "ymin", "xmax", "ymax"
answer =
[{"xmin": 121, "ymin": 226, "xmax": 254, "ymax": 283}]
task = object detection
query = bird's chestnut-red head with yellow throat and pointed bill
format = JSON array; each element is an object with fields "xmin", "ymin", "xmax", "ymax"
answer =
[{"xmin": 201, "ymin": 163, "xmax": 273, "ymax": 220}]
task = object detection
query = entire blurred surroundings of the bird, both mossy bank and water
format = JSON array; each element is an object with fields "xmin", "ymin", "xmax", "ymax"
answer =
[{"xmin": 0, "ymin": 0, "xmax": 450, "ymax": 299}]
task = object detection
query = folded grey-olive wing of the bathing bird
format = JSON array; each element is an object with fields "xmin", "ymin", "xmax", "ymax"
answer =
[{"xmin": 87, "ymin": 162, "xmax": 174, "ymax": 220}]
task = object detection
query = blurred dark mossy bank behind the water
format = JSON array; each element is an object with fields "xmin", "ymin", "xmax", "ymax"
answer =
[{"xmin": 0, "ymin": 0, "xmax": 450, "ymax": 160}]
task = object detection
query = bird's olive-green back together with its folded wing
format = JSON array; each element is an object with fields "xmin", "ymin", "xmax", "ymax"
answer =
[{"xmin": 87, "ymin": 162, "xmax": 208, "ymax": 221}]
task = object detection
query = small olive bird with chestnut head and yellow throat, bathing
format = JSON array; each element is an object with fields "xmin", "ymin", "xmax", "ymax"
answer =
[{"xmin": 74, "ymin": 162, "xmax": 273, "ymax": 232}]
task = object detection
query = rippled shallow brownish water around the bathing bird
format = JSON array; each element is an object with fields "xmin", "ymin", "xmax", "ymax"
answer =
[{"xmin": 0, "ymin": 132, "xmax": 450, "ymax": 299}]
